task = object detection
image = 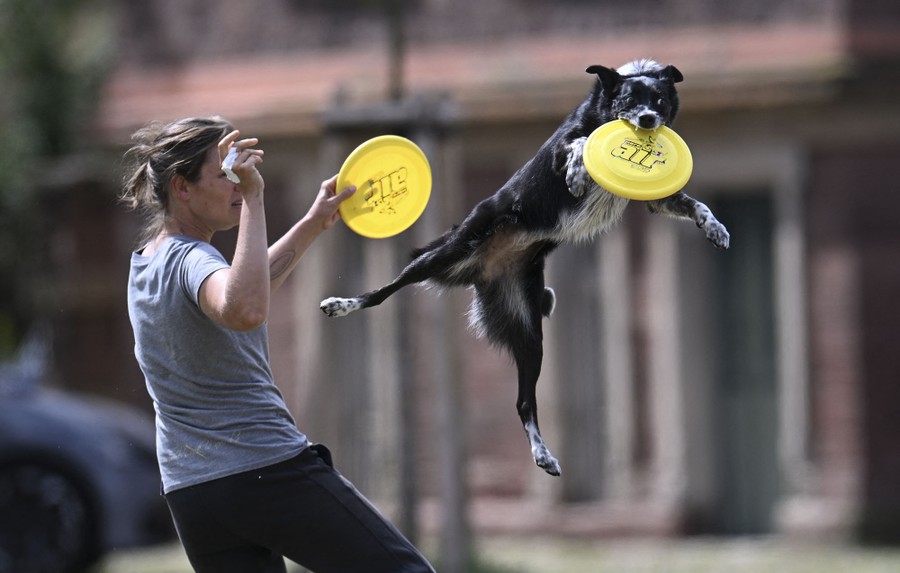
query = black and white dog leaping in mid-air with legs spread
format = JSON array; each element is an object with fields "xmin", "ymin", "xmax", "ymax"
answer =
[{"xmin": 320, "ymin": 60, "xmax": 730, "ymax": 475}]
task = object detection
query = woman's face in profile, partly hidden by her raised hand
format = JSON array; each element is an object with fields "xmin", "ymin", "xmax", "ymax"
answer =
[{"xmin": 187, "ymin": 147, "xmax": 243, "ymax": 233}]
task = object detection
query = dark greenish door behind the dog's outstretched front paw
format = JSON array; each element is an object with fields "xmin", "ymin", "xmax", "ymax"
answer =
[{"xmin": 712, "ymin": 194, "xmax": 780, "ymax": 535}]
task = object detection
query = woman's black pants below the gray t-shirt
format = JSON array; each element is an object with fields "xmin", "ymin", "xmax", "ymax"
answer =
[{"xmin": 166, "ymin": 445, "xmax": 434, "ymax": 573}]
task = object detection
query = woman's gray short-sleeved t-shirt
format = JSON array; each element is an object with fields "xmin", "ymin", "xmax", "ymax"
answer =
[{"xmin": 128, "ymin": 237, "xmax": 309, "ymax": 493}]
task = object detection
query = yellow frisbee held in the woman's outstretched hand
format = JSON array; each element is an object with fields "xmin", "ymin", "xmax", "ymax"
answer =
[{"xmin": 337, "ymin": 135, "xmax": 431, "ymax": 239}]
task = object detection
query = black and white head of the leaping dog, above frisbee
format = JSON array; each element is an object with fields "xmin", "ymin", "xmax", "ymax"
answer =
[{"xmin": 587, "ymin": 60, "xmax": 684, "ymax": 129}]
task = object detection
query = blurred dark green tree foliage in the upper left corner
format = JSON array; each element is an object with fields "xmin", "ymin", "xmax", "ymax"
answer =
[{"xmin": 0, "ymin": 0, "xmax": 113, "ymax": 358}]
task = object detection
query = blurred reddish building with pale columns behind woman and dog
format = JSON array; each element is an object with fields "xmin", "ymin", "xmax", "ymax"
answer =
[{"xmin": 47, "ymin": 0, "xmax": 900, "ymax": 541}]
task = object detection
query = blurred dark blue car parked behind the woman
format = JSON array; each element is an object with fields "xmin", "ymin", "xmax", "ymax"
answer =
[{"xmin": 0, "ymin": 354, "xmax": 175, "ymax": 573}]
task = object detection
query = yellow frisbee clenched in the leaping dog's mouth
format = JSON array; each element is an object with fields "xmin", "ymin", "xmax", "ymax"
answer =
[{"xmin": 584, "ymin": 119, "xmax": 694, "ymax": 201}]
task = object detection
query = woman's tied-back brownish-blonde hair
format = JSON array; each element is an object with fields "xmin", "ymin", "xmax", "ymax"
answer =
[{"xmin": 120, "ymin": 116, "xmax": 234, "ymax": 245}]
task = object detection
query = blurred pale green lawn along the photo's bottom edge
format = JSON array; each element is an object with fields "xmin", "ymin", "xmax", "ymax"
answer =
[{"xmin": 92, "ymin": 538, "xmax": 900, "ymax": 573}]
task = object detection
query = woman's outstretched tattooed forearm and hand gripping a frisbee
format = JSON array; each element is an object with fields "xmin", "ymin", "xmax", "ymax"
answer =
[{"xmin": 268, "ymin": 175, "xmax": 356, "ymax": 292}]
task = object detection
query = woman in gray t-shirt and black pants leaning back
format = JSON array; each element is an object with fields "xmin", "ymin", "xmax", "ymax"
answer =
[{"xmin": 123, "ymin": 117, "xmax": 433, "ymax": 573}]
